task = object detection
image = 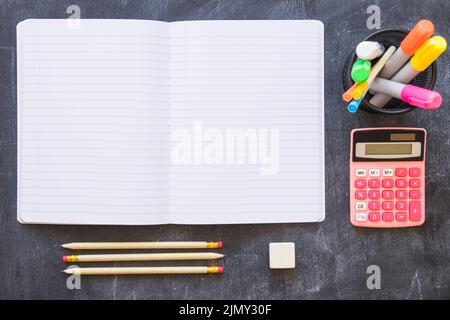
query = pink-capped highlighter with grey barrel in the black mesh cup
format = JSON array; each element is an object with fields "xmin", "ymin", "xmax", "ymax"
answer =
[{"xmin": 370, "ymin": 78, "xmax": 442, "ymax": 110}]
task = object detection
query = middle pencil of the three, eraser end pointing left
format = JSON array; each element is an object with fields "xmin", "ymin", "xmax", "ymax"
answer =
[{"xmin": 62, "ymin": 252, "xmax": 224, "ymax": 262}]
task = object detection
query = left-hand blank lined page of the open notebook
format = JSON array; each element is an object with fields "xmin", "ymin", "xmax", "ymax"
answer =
[{"xmin": 17, "ymin": 20, "xmax": 169, "ymax": 224}]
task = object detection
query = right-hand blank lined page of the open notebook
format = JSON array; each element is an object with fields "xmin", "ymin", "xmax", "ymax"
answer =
[{"xmin": 169, "ymin": 21, "xmax": 325, "ymax": 224}]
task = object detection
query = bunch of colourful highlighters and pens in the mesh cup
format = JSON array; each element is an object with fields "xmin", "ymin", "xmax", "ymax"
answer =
[{"xmin": 342, "ymin": 20, "xmax": 447, "ymax": 113}]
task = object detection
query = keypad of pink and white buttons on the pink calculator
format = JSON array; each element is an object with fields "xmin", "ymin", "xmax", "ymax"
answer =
[{"xmin": 352, "ymin": 167, "xmax": 423, "ymax": 226}]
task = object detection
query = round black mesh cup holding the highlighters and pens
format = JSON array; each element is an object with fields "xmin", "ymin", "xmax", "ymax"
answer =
[{"xmin": 342, "ymin": 29, "xmax": 437, "ymax": 114}]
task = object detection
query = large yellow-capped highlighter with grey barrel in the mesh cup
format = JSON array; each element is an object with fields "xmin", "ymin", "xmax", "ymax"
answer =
[{"xmin": 369, "ymin": 36, "xmax": 447, "ymax": 108}]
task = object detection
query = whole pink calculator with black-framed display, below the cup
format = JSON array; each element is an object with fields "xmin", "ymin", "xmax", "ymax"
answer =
[{"xmin": 350, "ymin": 128, "xmax": 426, "ymax": 228}]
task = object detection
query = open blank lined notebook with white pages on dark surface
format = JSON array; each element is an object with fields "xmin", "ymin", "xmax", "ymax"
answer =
[{"xmin": 17, "ymin": 19, "xmax": 325, "ymax": 224}]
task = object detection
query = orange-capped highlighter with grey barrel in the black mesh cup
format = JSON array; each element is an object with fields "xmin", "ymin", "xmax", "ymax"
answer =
[{"xmin": 380, "ymin": 20, "xmax": 434, "ymax": 79}]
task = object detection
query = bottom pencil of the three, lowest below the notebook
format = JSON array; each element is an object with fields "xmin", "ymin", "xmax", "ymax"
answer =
[{"xmin": 63, "ymin": 267, "xmax": 223, "ymax": 275}]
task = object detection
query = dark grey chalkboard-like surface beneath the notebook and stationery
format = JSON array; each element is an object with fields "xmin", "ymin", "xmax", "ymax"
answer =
[{"xmin": 0, "ymin": 0, "xmax": 450, "ymax": 299}]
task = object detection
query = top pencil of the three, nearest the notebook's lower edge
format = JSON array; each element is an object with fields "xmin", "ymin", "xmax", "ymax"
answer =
[{"xmin": 62, "ymin": 241, "xmax": 222, "ymax": 250}]
